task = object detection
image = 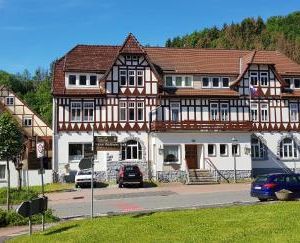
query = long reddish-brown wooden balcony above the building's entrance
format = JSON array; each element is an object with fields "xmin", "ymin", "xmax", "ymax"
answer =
[{"xmin": 151, "ymin": 120, "xmax": 252, "ymax": 132}]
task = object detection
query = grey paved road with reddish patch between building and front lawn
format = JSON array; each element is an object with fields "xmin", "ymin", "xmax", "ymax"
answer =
[{"xmin": 49, "ymin": 185, "xmax": 257, "ymax": 217}]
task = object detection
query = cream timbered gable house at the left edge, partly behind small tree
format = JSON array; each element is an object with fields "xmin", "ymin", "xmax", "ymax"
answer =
[{"xmin": 0, "ymin": 86, "xmax": 53, "ymax": 187}]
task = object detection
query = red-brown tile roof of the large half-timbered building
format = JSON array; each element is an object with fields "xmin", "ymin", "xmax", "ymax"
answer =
[{"xmin": 53, "ymin": 34, "xmax": 300, "ymax": 95}]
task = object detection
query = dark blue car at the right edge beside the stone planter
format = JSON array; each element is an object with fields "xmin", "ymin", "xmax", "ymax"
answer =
[{"xmin": 250, "ymin": 173, "xmax": 300, "ymax": 201}]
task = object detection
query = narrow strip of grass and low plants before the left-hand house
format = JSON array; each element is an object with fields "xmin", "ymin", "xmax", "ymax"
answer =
[{"xmin": 0, "ymin": 183, "xmax": 74, "ymax": 205}]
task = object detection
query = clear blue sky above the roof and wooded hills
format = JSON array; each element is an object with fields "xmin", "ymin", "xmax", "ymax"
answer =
[{"xmin": 0, "ymin": 0, "xmax": 300, "ymax": 73}]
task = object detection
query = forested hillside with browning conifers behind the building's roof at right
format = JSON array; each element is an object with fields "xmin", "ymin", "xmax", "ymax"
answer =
[{"xmin": 166, "ymin": 11, "xmax": 300, "ymax": 63}]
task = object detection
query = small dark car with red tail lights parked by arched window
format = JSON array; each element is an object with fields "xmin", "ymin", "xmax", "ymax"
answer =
[{"xmin": 117, "ymin": 165, "xmax": 144, "ymax": 187}]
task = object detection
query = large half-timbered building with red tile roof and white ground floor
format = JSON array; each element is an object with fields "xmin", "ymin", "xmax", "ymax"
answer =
[{"xmin": 53, "ymin": 34, "xmax": 300, "ymax": 181}]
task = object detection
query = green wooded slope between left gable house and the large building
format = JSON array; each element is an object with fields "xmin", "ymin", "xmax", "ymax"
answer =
[{"xmin": 0, "ymin": 68, "xmax": 52, "ymax": 125}]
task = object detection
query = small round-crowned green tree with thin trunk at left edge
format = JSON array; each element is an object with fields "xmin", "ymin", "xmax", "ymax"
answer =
[{"xmin": 0, "ymin": 112, "xmax": 23, "ymax": 210}]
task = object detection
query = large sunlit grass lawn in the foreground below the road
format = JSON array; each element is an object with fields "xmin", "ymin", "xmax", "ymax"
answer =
[{"xmin": 13, "ymin": 202, "xmax": 300, "ymax": 243}]
